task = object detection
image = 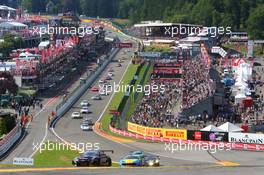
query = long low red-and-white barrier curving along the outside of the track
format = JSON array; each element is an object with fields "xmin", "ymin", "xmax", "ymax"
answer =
[{"xmin": 109, "ymin": 125, "xmax": 264, "ymax": 151}]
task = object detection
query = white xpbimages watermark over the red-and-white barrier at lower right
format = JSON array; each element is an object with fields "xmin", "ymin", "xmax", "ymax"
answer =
[{"xmin": 164, "ymin": 141, "xmax": 232, "ymax": 154}]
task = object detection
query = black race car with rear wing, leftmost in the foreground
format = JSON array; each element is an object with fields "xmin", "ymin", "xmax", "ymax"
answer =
[{"xmin": 72, "ymin": 150, "xmax": 114, "ymax": 166}]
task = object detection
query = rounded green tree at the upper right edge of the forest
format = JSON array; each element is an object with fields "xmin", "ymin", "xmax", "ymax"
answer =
[{"xmin": 247, "ymin": 5, "xmax": 264, "ymax": 39}]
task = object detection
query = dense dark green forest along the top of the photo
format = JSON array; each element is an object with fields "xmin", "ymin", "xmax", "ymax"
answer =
[{"xmin": 1, "ymin": 0, "xmax": 264, "ymax": 38}]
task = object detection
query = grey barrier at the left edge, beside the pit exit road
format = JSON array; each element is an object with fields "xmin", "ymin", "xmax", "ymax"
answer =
[{"xmin": 0, "ymin": 125, "xmax": 22, "ymax": 158}]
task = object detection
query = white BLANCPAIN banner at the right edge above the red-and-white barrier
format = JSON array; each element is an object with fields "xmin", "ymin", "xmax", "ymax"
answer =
[{"xmin": 228, "ymin": 132, "xmax": 264, "ymax": 144}]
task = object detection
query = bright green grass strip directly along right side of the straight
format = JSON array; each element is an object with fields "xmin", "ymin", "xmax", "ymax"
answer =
[{"xmin": 101, "ymin": 64, "xmax": 139, "ymax": 134}]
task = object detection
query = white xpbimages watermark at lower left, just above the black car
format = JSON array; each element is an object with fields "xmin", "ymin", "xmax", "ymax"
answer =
[{"xmin": 32, "ymin": 140, "xmax": 100, "ymax": 153}]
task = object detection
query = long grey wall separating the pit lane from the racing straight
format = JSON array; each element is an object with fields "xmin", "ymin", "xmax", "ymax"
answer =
[{"xmin": 50, "ymin": 49, "xmax": 119, "ymax": 127}]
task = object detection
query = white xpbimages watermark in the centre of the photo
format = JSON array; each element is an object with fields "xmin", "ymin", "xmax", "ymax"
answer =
[{"xmin": 99, "ymin": 82, "xmax": 166, "ymax": 95}]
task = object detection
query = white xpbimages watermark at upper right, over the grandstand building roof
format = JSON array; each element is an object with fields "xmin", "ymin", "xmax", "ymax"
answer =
[{"xmin": 165, "ymin": 24, "xmax": 232, "ymax": 37}]
